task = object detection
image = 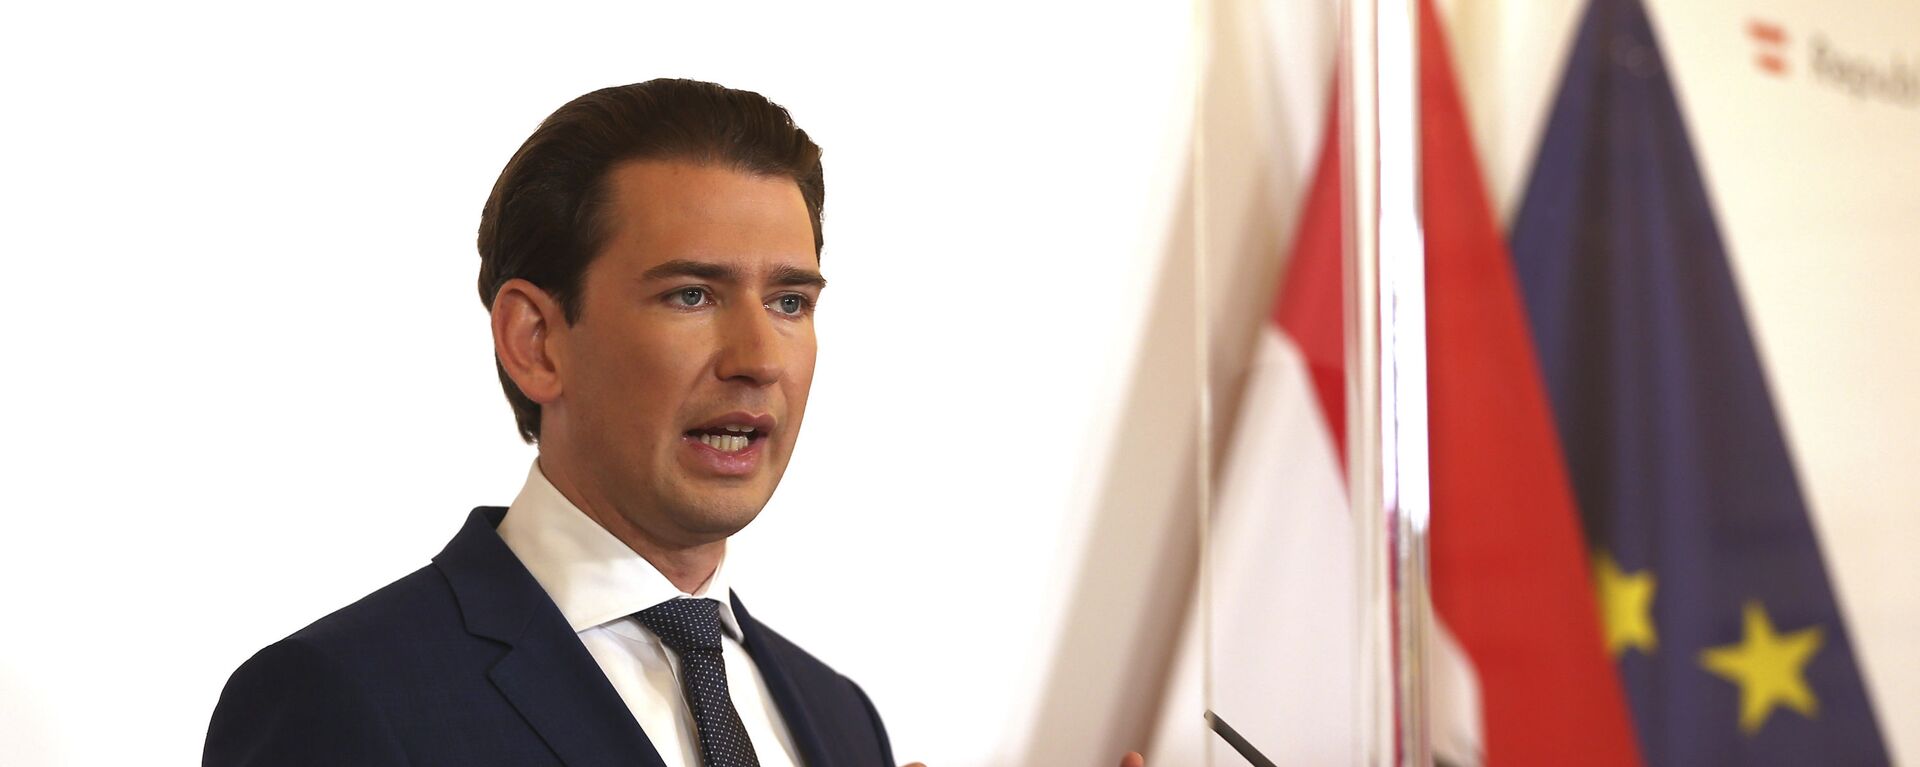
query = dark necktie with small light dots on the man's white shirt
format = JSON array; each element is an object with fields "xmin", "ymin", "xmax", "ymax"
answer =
[{"xmin": 634, "ymin": 598, "xmax": 760, "ymax": 767}]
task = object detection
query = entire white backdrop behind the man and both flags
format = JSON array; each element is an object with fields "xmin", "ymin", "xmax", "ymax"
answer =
[{"xmin": 0, "ymin": 0, "xmax": 1920, "ymax": 765}]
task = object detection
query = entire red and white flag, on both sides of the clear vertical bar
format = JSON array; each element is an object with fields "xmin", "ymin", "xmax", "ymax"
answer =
[{"xmin": 1148, "ymin": 2, "xmax": 1640, "ymax": 767}]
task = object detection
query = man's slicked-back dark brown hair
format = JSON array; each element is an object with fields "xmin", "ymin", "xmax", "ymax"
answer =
[{"xmin": 480, "ymin": 79, "xmax": 826, "ymax": 442}]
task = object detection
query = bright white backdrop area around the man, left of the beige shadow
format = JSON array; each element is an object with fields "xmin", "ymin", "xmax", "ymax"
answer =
[{"xmin": 0, "ymin": 2, "xmax": 1192, "ymax": 765}]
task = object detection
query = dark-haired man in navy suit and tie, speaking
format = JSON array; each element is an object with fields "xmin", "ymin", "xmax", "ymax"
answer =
[{"xmin": 204, "ymin": 81, "xmax": 895, "ymax": 767}]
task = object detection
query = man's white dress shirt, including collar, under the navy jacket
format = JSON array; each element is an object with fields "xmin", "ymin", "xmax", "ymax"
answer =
[{"xmin": 499, "ymin": 461, "xmax": 801, "ymax": 767}]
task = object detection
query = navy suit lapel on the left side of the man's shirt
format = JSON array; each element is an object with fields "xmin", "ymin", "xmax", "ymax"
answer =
[{"xmin": 434, "ymin": 507, "xmax": 672, "ymax": 767}]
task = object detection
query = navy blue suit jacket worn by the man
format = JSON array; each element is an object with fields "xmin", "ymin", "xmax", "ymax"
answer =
[{"xmin": 204, "ymin": 507, "xmax": 895, "ymax": 767}]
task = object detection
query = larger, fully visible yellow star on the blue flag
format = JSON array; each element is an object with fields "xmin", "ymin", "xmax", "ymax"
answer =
[{"xmin": 1699, "ymin": 602, "xmax": 1826, "ymax": 734}]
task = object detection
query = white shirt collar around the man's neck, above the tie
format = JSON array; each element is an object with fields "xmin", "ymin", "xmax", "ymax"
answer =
[{"xmin": 499, "ymin": 459, "xmax": 741, "ymax": 640}]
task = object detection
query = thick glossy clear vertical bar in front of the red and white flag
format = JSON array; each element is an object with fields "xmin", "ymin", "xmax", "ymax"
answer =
[{"xmin": 1340, "ymin": 0, "xmax": 1432, "ymax": 765}]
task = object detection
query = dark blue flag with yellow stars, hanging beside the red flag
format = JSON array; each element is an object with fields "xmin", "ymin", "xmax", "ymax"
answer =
[{"xmin": 1513, "ymin": 0, "xmax": 1887, "ymax": 767}]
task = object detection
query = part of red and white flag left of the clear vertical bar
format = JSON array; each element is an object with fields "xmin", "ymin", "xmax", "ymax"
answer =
[{"xmin": 1146, "ymin": 94, "xmax": 1363, "ymax": 767}]
